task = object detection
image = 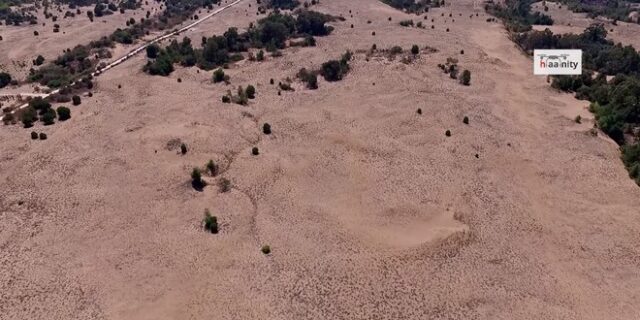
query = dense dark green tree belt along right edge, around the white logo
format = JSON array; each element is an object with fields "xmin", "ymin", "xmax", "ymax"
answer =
[{"xmin": 490, "ymin": 0, "xmax": 640, "ymax": 185}]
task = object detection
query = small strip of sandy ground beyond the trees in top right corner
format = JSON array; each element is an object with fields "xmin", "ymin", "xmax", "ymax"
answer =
[{"xmin": 532, "ymin": 1, "xmax": 640, "ymax": 50}]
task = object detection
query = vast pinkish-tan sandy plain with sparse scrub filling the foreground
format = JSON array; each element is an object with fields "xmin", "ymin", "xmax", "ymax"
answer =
[{"xmin": 0, "ymin": 0, "xmax": 640, "ymax": 320}]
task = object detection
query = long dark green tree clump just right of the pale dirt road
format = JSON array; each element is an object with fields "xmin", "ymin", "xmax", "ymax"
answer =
[{"xmin": 144, "ymin": 10, "xmax": 333, "ymax": 75}]
